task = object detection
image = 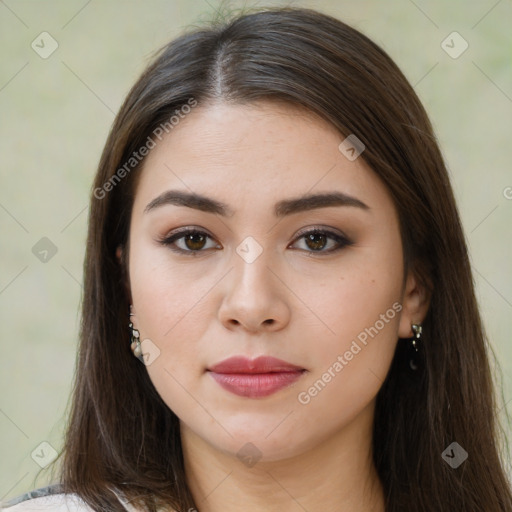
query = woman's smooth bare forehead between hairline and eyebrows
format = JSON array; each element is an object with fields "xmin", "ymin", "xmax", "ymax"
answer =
[{"xmin": 134, "ymin": 102, "xmax": 391, "ymax": 219}]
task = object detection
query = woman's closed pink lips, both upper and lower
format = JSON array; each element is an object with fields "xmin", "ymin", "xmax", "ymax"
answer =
[{"xmin": 208, "ymin": 356, "xmax": 306, "ymax": 398}]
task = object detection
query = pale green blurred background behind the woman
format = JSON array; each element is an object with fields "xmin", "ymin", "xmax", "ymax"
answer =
[{"xmin": 0, "ymin": 0, "xmax": 512, "ymax": 499}]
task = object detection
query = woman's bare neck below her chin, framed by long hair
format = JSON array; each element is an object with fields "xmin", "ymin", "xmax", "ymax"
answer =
[{"xmin": 181, "ymin": 403, "xmax": 385, "ymax": 512}]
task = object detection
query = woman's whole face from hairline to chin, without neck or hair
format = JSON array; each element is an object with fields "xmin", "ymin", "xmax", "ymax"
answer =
[{"xmin": 126, "ymin": 103, "xmax": 411, "ymax": 460}]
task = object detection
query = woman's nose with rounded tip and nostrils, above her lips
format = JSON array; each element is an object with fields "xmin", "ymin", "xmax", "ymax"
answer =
[{"xmin": 218, "ymin": 247, "xmax": 291, "ymax": 333}]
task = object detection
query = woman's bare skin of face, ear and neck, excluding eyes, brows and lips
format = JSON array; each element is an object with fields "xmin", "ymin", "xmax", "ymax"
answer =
[{"xmin": 122, "ymin": 102, "xmax": 428, "ymax": 512}]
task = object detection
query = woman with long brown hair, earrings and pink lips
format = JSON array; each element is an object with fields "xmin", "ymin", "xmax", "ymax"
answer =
[{"xmin": 5, "ymin": 8, "xmax": 512, "ymax": 512}]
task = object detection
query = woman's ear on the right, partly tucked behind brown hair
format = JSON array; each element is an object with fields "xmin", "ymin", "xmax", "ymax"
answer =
[{"xmin": 398, "ymin": 270, "xmax": 430, "ymax": 338}]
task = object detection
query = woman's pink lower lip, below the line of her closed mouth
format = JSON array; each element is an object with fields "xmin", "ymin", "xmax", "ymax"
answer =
[{"xmin": 208, "ymin": 370, "xmax": 304, "ymax": 398}]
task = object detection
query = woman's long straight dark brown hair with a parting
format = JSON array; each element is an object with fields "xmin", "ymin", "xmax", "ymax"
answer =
[{"xmin": 56, "ymin": 8, "xmax": 512, "ymax": 512}]
